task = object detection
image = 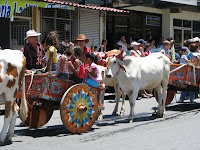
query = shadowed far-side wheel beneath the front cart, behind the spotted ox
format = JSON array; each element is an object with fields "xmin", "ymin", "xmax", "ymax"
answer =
[{"xmin": 25, "ymin": 99, "xmax": 54, "ymax": 128}]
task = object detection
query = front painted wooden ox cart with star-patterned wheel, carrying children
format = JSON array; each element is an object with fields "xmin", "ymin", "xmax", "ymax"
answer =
[{"xmin": 17, "ymin": 74, "xmax": 104, "ymax": 133}]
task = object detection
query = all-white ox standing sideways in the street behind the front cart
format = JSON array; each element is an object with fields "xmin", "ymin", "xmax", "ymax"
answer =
[{"xmin": 106, "ymin": 53, "xmax": 171, "ymax": 122}]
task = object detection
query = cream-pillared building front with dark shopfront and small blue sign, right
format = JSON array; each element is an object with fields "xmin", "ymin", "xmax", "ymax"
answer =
[{"xmin": 107, "ymin": 0, "xmax": 200, "ymax": 47}]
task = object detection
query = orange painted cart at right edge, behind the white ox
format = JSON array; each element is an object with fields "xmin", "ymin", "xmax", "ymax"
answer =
[{"xmin": 166, "ymin": 64, "xmax": 200, "ymax": 105}]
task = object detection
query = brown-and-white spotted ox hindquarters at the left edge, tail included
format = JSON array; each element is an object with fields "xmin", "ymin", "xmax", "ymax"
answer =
[{"xmin": 0, "ymin": 50, "xmax": 28, "ymax": 145}]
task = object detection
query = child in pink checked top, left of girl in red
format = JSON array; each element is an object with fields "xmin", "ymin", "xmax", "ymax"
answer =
[{"xmin": 55, "ymin": 42, "xmax": 72, "ymax": 79}]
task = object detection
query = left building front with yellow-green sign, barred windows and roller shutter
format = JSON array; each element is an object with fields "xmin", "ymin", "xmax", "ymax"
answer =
[{"xmin": 0, "ymin": 0, "xmax": 126, "ymax": 49}]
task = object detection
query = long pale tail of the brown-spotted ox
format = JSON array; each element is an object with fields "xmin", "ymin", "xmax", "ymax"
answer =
[{"xmin": 19, "ymin": 76, "xmax": 28, "ymax": 123}]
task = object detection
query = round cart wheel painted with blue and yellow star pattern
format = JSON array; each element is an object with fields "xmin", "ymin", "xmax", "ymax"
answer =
[{"xmin": 60, "ymin": 84, "xmax": 98, "ymax": 133}]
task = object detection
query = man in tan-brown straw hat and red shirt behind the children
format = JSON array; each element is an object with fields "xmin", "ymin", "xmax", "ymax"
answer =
[{"xmin": 74, "ymin": 34, "xmax": 91, "ymax": 63}]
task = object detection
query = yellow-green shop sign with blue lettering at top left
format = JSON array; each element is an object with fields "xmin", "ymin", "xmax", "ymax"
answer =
[{"xmin": 0, "ymin": 0, "xmax": 74, "ymax": 18}]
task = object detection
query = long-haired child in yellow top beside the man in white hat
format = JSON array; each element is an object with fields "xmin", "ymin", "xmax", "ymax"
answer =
[{"xmin": 45, "ymin": 31, "xmax": 59, "ymax": 73}]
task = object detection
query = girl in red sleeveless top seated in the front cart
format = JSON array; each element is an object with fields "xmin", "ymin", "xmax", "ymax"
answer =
[{"xmin": 69, "ymin": 47, "xmax": 85, "ymax": 83}]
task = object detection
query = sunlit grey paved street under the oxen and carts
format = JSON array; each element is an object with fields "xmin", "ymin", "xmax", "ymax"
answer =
[{"xmin": 0, "ymin": 95, "xmax": 200, "ymax": 150}]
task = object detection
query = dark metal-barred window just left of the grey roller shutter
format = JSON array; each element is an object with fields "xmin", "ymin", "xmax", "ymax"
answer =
[{"xmin": 41, "ymin": 8, "xmax": 78, "ymax": 42}]
